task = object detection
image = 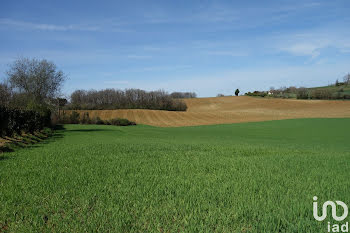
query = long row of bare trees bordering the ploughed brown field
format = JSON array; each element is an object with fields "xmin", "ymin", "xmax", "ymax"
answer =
[{"xmin": 65, "ymin": 89, "xmax": 190, "ymax": 111}]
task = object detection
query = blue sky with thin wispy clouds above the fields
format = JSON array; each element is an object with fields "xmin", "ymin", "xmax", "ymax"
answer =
[{"xmin": 0, "ymin": 0, "xmax": 350, "ymax": 97}]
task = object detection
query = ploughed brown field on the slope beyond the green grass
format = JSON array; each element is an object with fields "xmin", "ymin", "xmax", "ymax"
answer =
[{"xmin": 66, "ymin": 96, "xmax": 350, "ymax": 127}]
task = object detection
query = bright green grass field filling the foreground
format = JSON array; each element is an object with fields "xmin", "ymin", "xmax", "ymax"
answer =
[{"xmin": 0, "ymin": 119, "xmax": 350, "ymax": 232}]
